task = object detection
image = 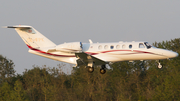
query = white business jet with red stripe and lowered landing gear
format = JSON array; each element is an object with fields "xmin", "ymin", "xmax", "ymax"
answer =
[{"xmin": 6, "ymin": 25, "xmax": 178, "ymax": 74}]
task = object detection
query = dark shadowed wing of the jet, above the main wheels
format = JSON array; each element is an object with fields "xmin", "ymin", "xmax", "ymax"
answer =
[{"xmin": 75, "ymin": 52, "xmax": 107, "ymax": 66}]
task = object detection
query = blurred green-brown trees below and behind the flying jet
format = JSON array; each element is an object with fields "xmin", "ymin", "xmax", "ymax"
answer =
[{"xmin": 0, "ymin": 39, "xmax": 180, "ymax": 101}]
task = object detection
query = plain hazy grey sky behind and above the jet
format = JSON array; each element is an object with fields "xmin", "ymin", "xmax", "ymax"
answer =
[{"xmin": 0, "ymin": 0, "xmax": 180, "ymax": 74}]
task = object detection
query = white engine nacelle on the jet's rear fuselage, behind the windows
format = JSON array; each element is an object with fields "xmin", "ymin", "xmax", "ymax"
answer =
[{"xmin": 56, "ymin": 42, "xmax": 82, "ymax": 53}]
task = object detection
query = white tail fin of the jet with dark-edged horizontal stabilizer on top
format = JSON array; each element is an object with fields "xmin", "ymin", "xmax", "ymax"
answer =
[{"xmin": 6, "ymin": 25, "xmax": 56, "ymax": 49}]
